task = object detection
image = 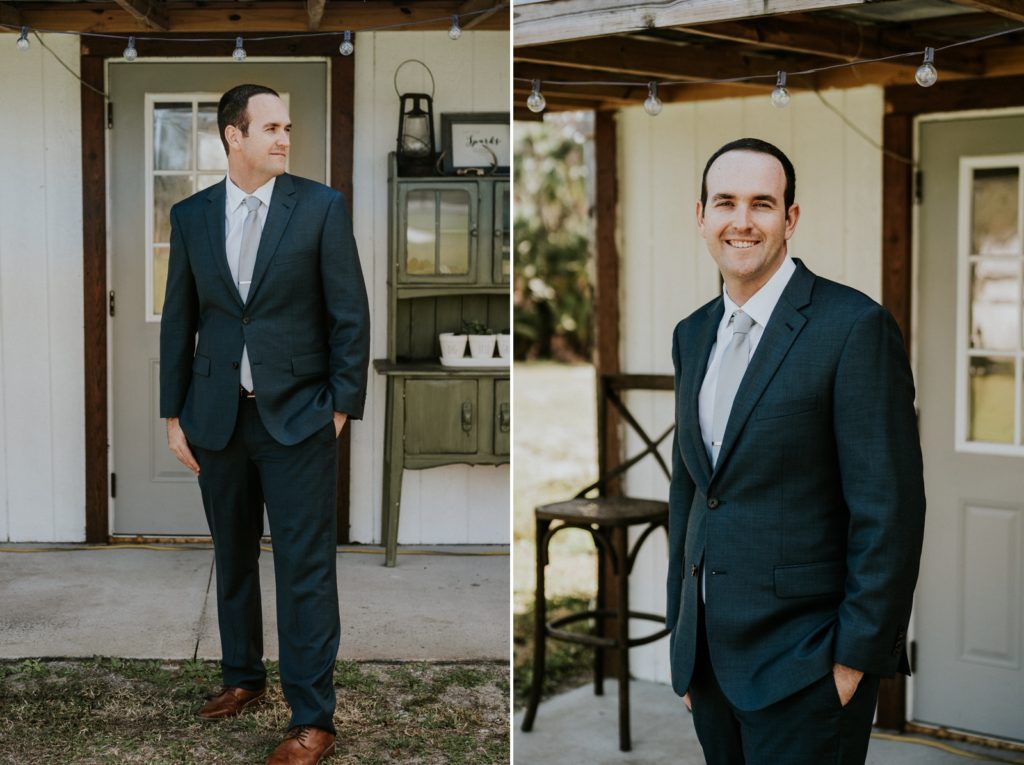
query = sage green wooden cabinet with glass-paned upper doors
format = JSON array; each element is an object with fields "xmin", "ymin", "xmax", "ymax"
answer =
[{"xmin": 374, "ymin": 155, "xmax": 512, "ymax": 566}]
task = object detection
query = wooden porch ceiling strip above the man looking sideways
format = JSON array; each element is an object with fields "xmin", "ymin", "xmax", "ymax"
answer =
[{"xmin": 0, "ymin": 0, "xmax": 509, "ymax": 34}]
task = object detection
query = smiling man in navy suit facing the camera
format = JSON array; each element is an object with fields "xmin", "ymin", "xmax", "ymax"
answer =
[{"xmin": 668, "ymin": 138, "xmax": 925, "ymax": 765}]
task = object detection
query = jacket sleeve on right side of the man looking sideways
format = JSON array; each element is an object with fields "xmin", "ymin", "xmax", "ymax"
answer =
[{"xmin": 321, "ymin": 194, "xmax": 370, "ymax": 420}]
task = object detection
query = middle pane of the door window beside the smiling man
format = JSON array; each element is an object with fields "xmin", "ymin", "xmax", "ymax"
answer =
[{"xmin": 968, "ymin": 258, "xmax": 1021, "ymax": 350}]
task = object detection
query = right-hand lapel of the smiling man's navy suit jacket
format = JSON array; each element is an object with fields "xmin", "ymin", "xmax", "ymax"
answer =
[{"xmin": 714, "ymin": 259, "xmax": 814, "ymax": 475}]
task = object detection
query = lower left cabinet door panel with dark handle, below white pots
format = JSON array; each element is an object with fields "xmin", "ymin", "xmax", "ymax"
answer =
[{"xmin": 406, "ymin": 380, "xmax": 481, "ymax": 455}]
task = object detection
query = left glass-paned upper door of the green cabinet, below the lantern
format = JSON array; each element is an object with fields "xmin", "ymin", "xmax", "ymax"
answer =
[{"xmin": 398, "ymin": 183, "xmax": 477, "ymax": 284}]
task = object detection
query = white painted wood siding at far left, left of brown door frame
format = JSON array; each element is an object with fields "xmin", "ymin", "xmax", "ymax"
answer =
[{"xmin": 0, "ymin": 35, "xmax": 85, "ymax": 542}]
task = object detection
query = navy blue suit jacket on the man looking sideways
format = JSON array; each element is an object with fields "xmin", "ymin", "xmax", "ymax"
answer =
[{"xmin": 160, "ymin": 174, "xmax": 370, "ymax": 450}]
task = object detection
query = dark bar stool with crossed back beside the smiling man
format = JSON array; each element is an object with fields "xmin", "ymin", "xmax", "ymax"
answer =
[{"xmin": 522, "ymin": 375, "xmax": 675, "ymax": 752}]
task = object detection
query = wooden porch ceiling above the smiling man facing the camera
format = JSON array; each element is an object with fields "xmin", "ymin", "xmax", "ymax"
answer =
[{"xmin": 513, "ymin": 0, "xmax": 1024, "ymax": 120}]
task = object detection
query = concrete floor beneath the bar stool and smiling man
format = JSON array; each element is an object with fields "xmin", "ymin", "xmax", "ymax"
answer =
[{"xmin": 512, "ymin": 680, "xmax": 1024, "ymax": 765}]
